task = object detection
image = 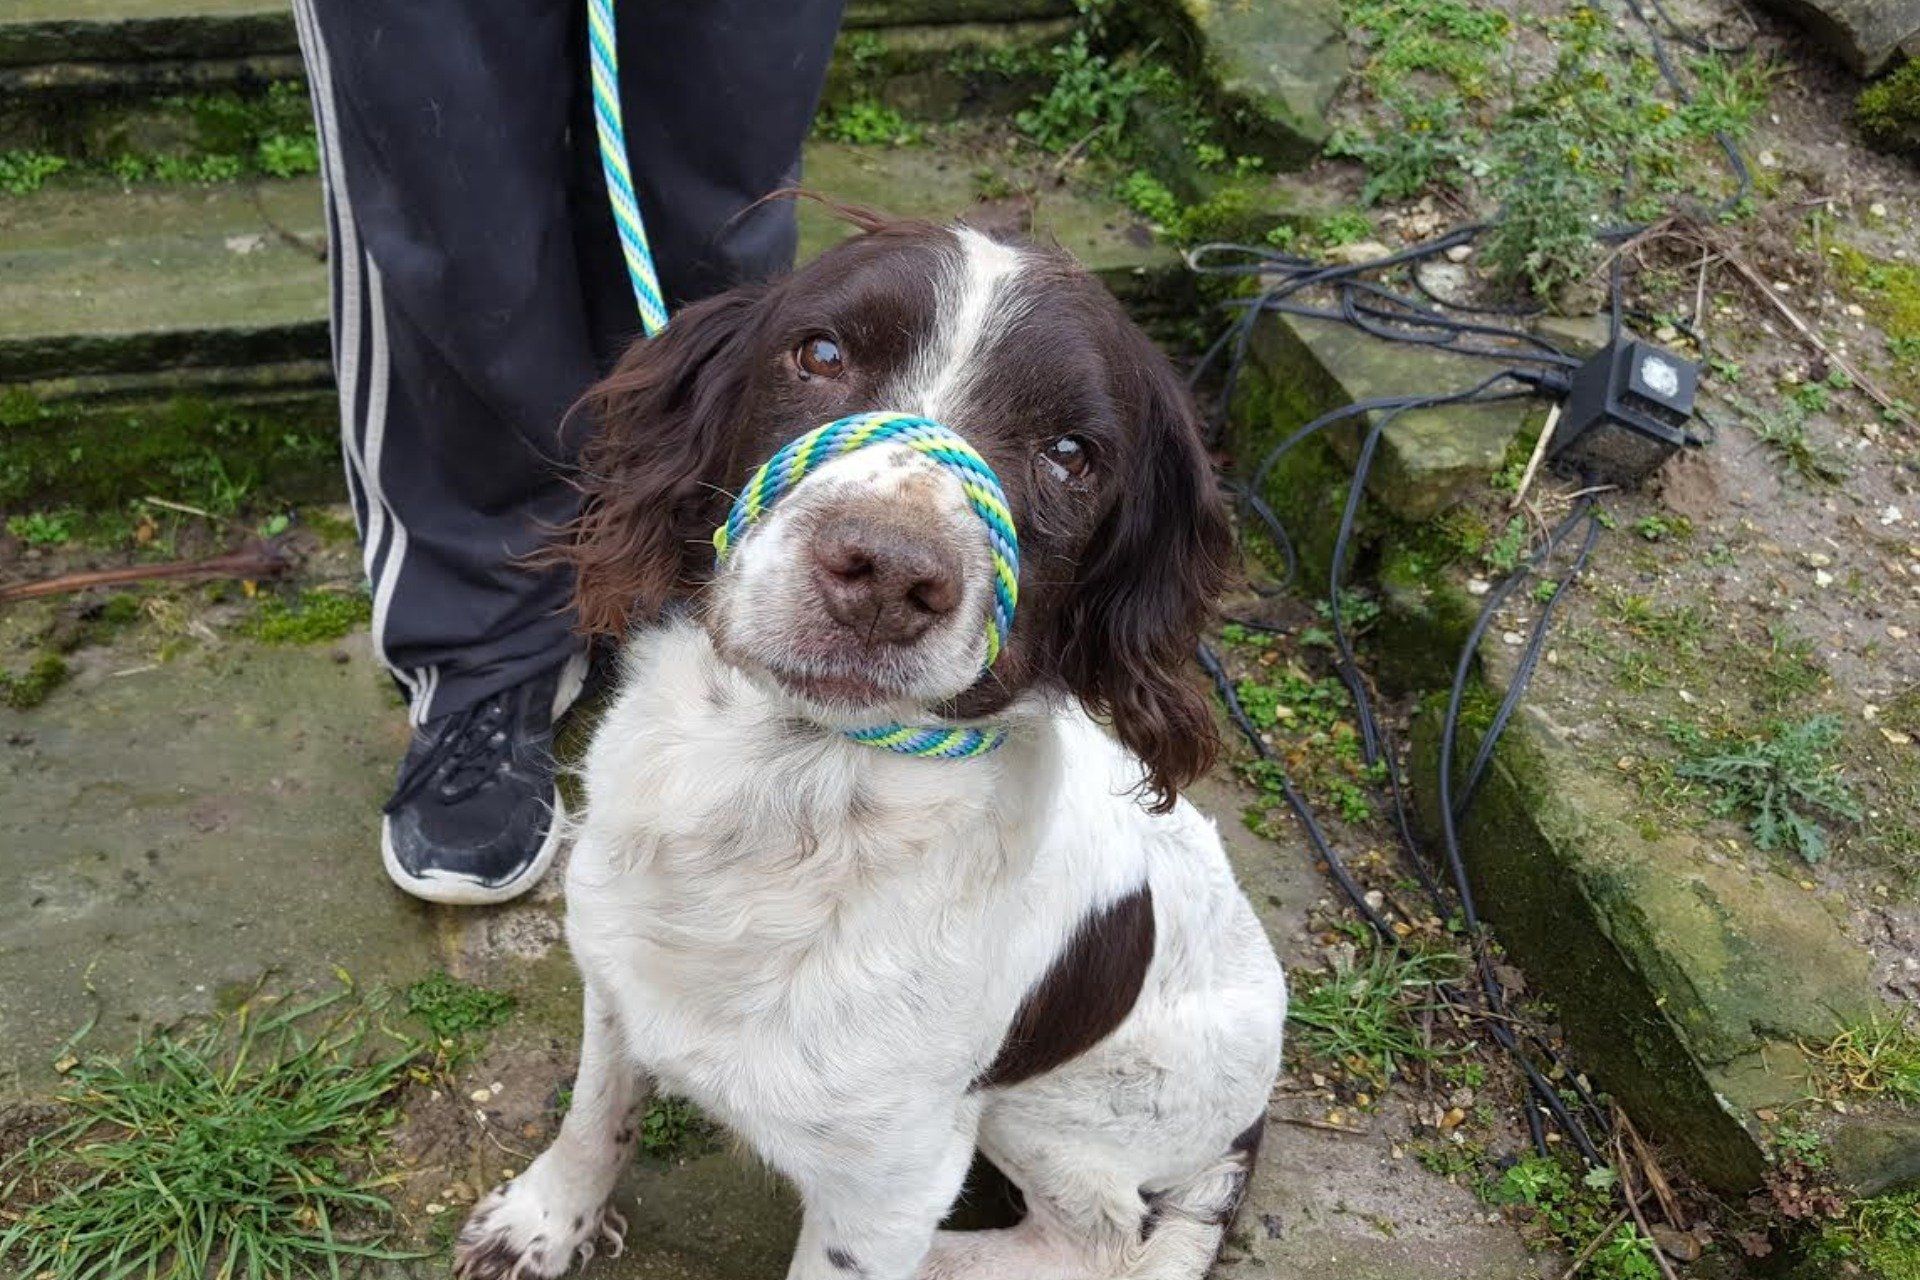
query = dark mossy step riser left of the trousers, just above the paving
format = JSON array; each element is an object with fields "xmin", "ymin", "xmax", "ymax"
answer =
[{"xmin": 0, "ymin": 390, "xmax": 340, "ymax": 516}]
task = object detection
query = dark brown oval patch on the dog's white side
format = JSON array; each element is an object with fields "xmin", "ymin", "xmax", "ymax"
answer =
[{"xmin": 973, "ymin": 885, "xmax": 1154, "ymax": 1088}]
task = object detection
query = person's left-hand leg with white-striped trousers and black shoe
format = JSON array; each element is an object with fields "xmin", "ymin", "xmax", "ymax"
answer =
[{"xmin": 296, "ymin": 0, "xmax": 599, "ymax": 902}]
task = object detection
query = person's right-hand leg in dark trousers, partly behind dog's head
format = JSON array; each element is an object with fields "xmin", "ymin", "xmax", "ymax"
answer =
[{"xmin": 574, "ymin": 0, "xmax": 843, "ymax": 359}]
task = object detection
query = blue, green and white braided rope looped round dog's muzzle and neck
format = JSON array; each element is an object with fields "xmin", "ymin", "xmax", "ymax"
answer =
[{"xmin": 714, "ymin": 413, "xmax": 1020, "ymax": 760}]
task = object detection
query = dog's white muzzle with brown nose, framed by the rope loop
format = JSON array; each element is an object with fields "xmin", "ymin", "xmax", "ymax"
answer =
[{"xmin": 707, "ymin": 443, "xmax": 993, "ymax": 722}]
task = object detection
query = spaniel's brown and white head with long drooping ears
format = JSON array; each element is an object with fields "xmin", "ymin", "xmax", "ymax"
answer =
[{"xmin": 563, "ymin": 214, "xmax": 1231, "ymax": 806}]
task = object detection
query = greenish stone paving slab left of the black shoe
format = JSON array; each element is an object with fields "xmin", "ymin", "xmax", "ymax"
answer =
[{"xmin": 0, "ymin": 635, "xmax": 436, "ymax": 1094}]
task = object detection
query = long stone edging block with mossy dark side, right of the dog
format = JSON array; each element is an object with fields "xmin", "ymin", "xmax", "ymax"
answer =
[{"xmin": 1411, "ymin": 695, "xmax": 1878, "ymax": 1194}]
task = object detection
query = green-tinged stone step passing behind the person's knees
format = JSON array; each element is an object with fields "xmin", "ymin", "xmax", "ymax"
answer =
[{"xmin": 0, "ymin": 142, "xmax": 1179, "ymax": 399}]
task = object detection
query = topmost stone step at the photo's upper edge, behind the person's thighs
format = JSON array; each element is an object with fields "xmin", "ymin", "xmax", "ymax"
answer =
[{"xmin": 0, "ymin": 0, "xmax": 1073, "ymax": 155}]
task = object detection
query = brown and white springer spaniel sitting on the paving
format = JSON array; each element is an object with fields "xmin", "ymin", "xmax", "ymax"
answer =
[{"xmin": 457, "ymin": 221, "xmax": 1286, "ymax": 1280}]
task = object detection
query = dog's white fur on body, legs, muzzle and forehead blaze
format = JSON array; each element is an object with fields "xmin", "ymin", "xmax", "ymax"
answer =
[{"xmin": 455, "ymin": 232, "xmax": 1286, "ymax": 1280}]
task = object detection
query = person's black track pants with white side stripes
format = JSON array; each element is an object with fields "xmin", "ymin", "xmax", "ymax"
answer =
[{"xmin": 294, "ymin": 0, "xmax": 841, "ymax": 723}]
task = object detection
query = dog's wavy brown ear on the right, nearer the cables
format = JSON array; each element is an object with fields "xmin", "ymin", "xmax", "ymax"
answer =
[{"xmin": 1060, "ymin": 330, "xmax": 1233, "ymax": 814}]
